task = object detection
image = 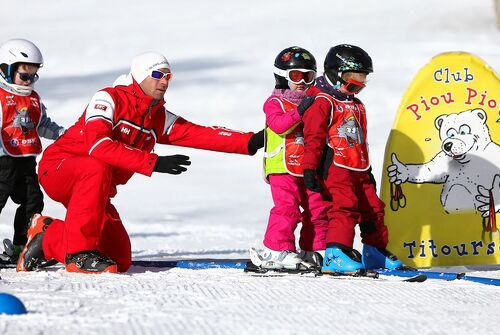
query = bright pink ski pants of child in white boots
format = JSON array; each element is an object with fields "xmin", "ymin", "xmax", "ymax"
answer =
[{"xmin": 264, "ymin": 174, "xmax": 328, "ymax": 251}]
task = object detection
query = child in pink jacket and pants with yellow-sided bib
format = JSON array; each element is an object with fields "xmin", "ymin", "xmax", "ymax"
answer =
[{"xmin": 250, "ymin": 47, "xmax": 328, "ymax": 269}]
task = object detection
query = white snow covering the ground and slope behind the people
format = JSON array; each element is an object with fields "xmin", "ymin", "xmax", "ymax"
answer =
[{"xmin": 0, "ymin": 0, "xmax": 500, "ymax": 335}]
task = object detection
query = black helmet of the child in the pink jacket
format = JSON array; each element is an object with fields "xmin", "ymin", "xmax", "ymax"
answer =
[{"xmin": 274, "ymin": 46, "xmax": 316, "ymax": 89}]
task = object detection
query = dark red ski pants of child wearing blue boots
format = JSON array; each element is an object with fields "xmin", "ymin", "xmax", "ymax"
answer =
[{"xmin": 324, "ymin": 164, "xmax": 388, "ymax": 248}]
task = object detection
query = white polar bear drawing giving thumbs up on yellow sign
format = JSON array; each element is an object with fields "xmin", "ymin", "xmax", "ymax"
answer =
[{"xmin": 387, "ymin": 108, "xmax": 500, "ymax": 217}]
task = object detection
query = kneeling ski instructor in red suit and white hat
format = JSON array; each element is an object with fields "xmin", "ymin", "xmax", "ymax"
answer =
[{"xmin": 17, "ymin": 52, "xmax": 264, "ymax": 273}]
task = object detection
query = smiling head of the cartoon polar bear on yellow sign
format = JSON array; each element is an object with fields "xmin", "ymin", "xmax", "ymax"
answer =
[{"xmin": 434, "ymin": 108, "xmax": 491, "ymax": 161}]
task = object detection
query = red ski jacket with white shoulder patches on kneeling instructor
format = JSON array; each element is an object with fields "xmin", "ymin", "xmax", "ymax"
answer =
[{"xmin": 40, "ymin": 80, "xmax": 253, "ymax": 185}]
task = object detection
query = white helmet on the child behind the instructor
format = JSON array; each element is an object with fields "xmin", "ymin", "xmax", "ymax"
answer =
[{"xmin": 0, "ymin": 38, "xmax": 43, "ymax": 83}]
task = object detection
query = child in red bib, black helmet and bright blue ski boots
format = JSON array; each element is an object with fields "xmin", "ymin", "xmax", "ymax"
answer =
[{"xmin": 303, "ymin": 44, "xmax": 402, "ymax": 273}]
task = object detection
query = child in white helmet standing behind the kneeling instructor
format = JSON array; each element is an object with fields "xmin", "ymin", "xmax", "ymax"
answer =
[{"xmin": 0, "ymin": 39, "xmax": 64, "ymax": 267}]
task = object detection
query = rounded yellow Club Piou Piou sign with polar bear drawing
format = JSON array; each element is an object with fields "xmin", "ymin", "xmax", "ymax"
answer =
[{"xmin": 381, "ymin": 52, "xmax": 500, "ymax": 267}]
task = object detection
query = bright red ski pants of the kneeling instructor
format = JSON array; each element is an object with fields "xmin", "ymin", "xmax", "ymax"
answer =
[{"xmin": 39, "ymin": 156, "xmax": 132, "ymax": 272}]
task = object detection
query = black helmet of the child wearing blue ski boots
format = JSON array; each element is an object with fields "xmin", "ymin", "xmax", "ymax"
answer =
[{"xmin": 325, "ymin": 44, "xmax": 373, "ymax": 83}]
